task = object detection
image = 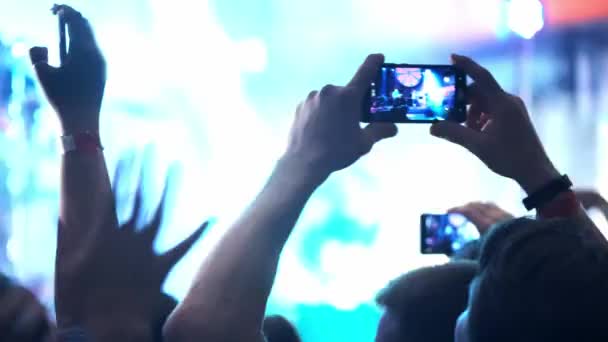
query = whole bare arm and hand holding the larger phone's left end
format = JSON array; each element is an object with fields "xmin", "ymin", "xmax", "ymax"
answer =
[{"xmin": 165, "ymin": 55, "xmax": 397, "ymax": 342}]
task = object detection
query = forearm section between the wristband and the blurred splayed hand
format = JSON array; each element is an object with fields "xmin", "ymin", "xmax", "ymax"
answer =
[{"xmin": 60, "ymin": 151, "xmax": 113, "ymax": 230}]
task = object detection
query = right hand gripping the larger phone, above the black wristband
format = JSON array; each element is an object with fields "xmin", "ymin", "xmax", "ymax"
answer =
[{"xmin": 431, "ymin": 55, "xmax": 559, "ymax": 193}]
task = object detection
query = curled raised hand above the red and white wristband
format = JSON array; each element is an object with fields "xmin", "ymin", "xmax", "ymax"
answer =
[{"xmin": 30, "ymin": 5, "xmax": 106, "ymax": 134}]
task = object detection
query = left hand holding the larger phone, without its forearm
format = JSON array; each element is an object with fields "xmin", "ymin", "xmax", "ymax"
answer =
[{"xmin": 286, "ymin": 55, "xmax": 397, "ymax": 176}]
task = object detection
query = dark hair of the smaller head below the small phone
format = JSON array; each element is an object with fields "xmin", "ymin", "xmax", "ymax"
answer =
[{"xmin": 377, "ymin": 261, "xmax": 477, "ymax": 342}]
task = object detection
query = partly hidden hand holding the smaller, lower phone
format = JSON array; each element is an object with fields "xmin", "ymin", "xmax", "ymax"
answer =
[{"xmin": 448, "ymin": 202, "xmax": 513, "ymax": 236}]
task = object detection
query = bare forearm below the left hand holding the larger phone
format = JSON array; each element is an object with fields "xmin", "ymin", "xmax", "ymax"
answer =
[{"xmin": 167, "ymin": 158, "xmax": 326, "ymax": 340}]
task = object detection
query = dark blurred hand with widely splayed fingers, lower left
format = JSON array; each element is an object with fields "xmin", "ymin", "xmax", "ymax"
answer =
[{"xmin": 56, "ymin": 175, "xmax": 207, "ymax": 337}]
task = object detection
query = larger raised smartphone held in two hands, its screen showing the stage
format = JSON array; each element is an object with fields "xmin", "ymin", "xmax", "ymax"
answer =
[{"xmin": 361, "ymin": 64, "xmax": 467, "ymax": 123}]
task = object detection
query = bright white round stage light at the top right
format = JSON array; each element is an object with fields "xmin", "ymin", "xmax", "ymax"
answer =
[{"xmin": 507, "ymin": 0, "xmax": 545, "ymax": 39}]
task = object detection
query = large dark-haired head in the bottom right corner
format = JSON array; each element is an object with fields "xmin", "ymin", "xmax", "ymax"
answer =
[{"xmin": 469, "ymin": 218, "xmax": 608, "ymax": 342}]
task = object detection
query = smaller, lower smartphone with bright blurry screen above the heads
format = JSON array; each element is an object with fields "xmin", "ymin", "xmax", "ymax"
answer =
[{"xmin": 420, "ymin": 214, "xmax": 479, "ymax": 256}]
